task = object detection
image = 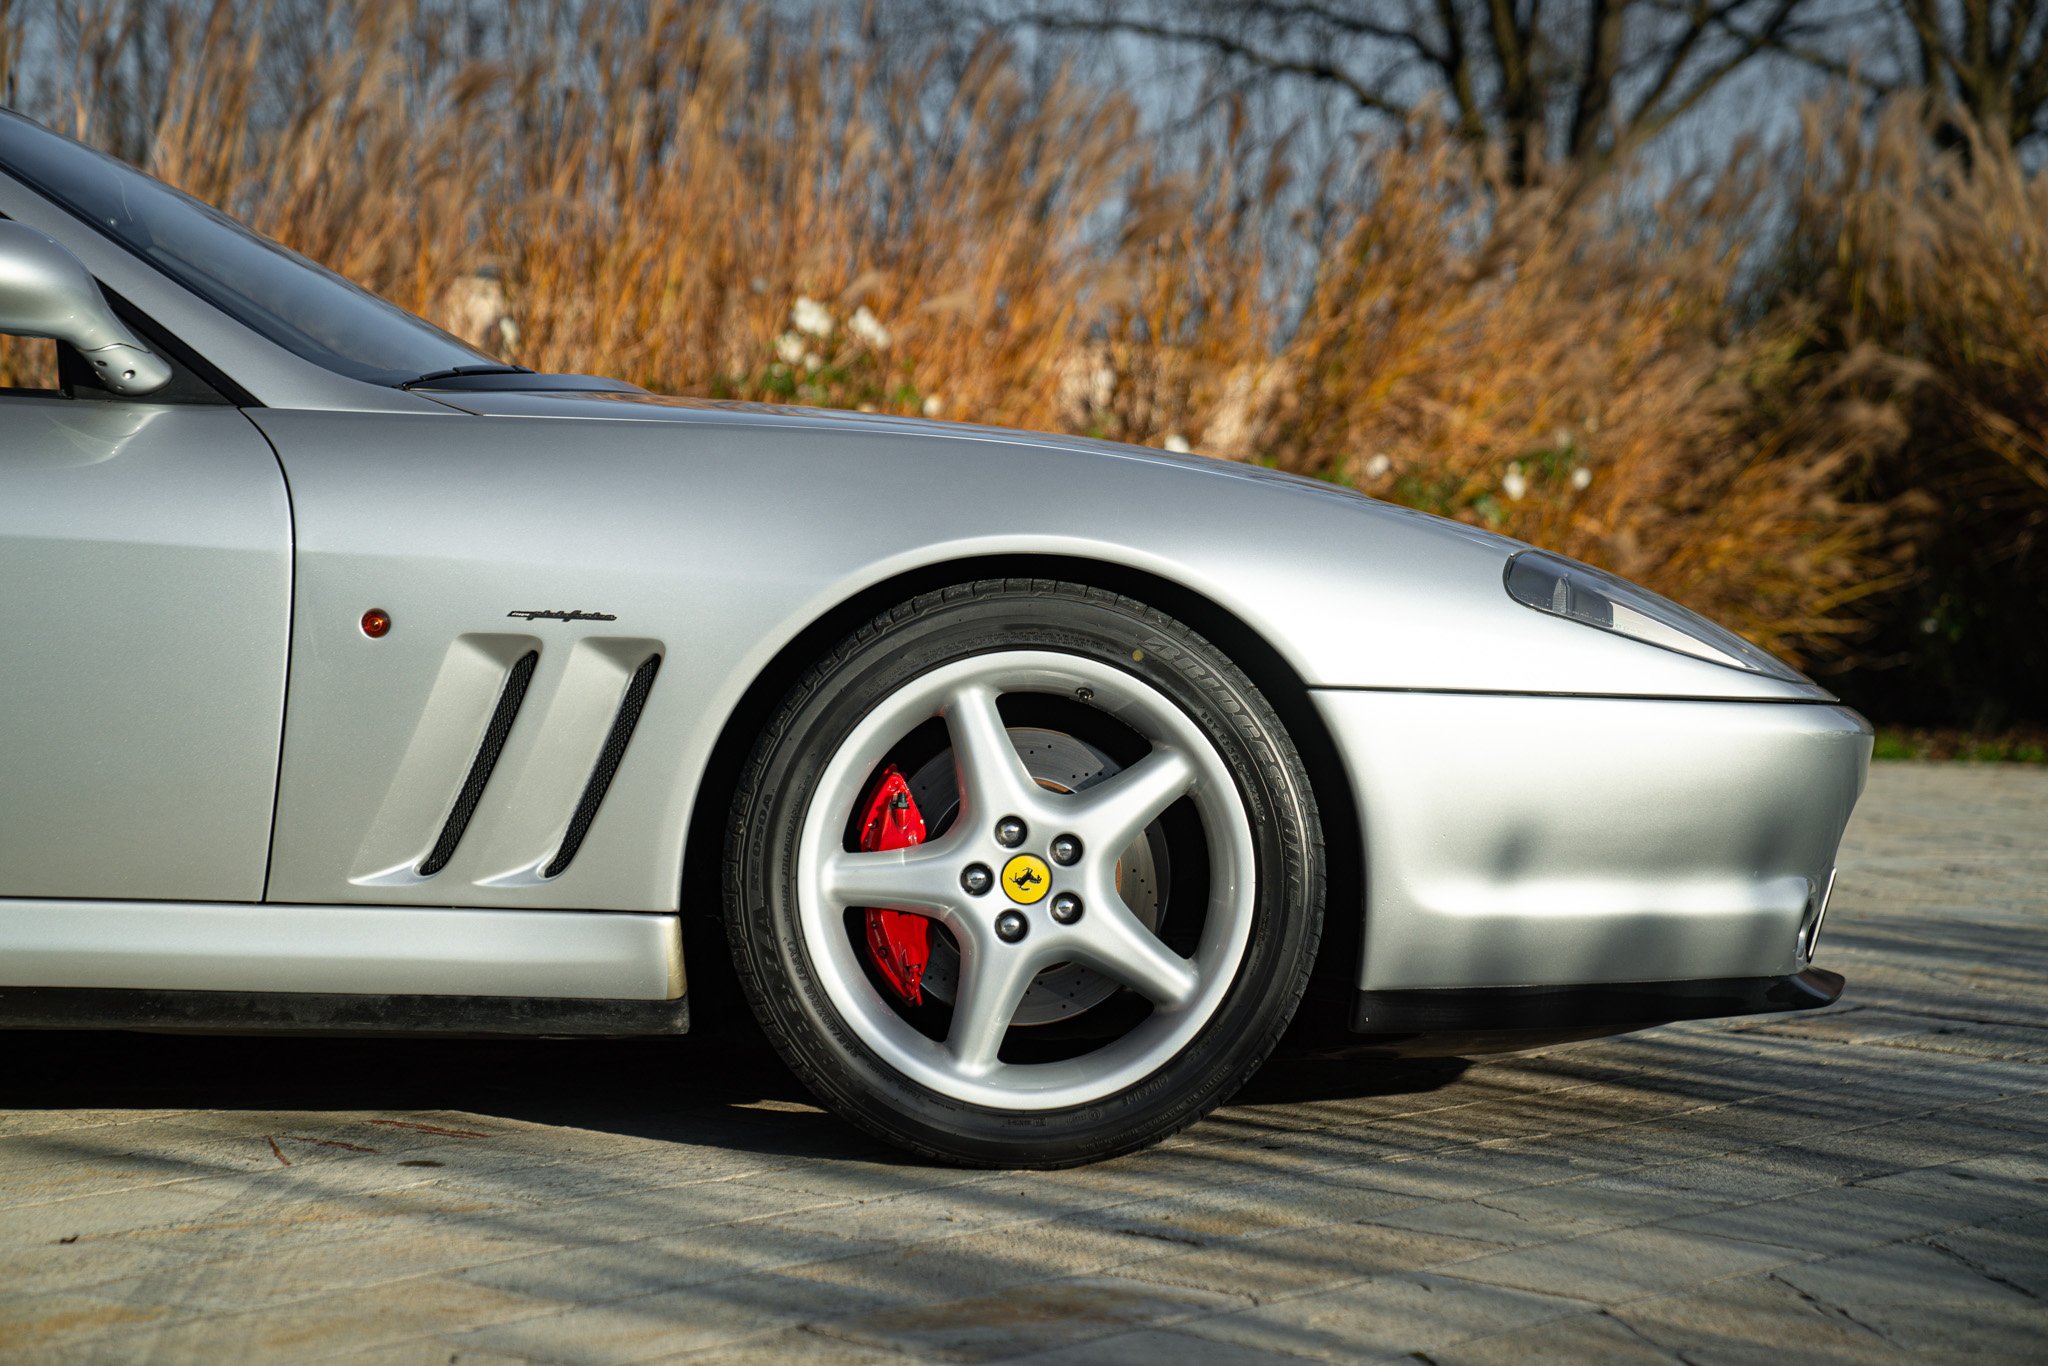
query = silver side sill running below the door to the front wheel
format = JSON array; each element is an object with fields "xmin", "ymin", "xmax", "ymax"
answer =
[{"xmin": 0, "ymin": 899, "xmax": 684, "ymax": 1001}]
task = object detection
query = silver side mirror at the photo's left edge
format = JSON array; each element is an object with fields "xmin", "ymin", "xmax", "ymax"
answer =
[{"xmin": 0, "ymin": 219, "xmax": 170, "ymax": 397}]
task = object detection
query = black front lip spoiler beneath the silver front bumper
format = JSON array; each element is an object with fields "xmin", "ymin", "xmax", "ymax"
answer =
[{"xmin": 1352, "ymin": 969, "xmax": 1845, "ymax": 1036}]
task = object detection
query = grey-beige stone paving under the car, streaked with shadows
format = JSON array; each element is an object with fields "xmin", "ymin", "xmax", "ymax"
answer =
[{"xmin": 0, "ymin": 764, "xmax": 2048, "ymax": 1366}]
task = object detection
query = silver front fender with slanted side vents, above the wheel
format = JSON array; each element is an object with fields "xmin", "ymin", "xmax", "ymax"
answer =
[{"xmin": 254, "ymin": 393, "xmax": 1825, "ymax": 925}]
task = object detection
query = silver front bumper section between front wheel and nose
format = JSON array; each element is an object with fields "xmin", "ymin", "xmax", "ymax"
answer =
[{"xmin": 1313, "ymin": 690, "xmax": 1872, "ymax": 993}]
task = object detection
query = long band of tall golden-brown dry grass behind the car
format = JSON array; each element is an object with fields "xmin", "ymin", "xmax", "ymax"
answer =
[{"xmin": 12, "ymin": 0, "xmax": 2048, "ymax": 684}]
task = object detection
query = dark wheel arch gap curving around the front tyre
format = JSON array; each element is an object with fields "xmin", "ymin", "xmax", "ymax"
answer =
[{"xmin": 680, "ymin": 555, "xmax": 1366, "ymax": 1032}]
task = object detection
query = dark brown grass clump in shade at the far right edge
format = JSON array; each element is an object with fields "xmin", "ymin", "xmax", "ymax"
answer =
[{"xmin": 1744, "ymin": 100, "xmax": 2048, "ymax": 716}]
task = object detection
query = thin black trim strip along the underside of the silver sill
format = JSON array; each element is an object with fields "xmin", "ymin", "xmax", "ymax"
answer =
[{"xmin": 0, "ymin": 987, "xmax": 690, "ymax": 1038}]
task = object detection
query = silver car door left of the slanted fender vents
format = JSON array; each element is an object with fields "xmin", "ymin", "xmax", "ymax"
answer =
[{"xmin": 0, "ymin": 338, "xmax": 291, "ymax": 901}]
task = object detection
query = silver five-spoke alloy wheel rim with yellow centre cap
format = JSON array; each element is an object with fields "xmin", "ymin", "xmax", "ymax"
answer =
[{"xmin": 799, "ymin": 649, "xmax": 1255, "ymax": 1110}]
